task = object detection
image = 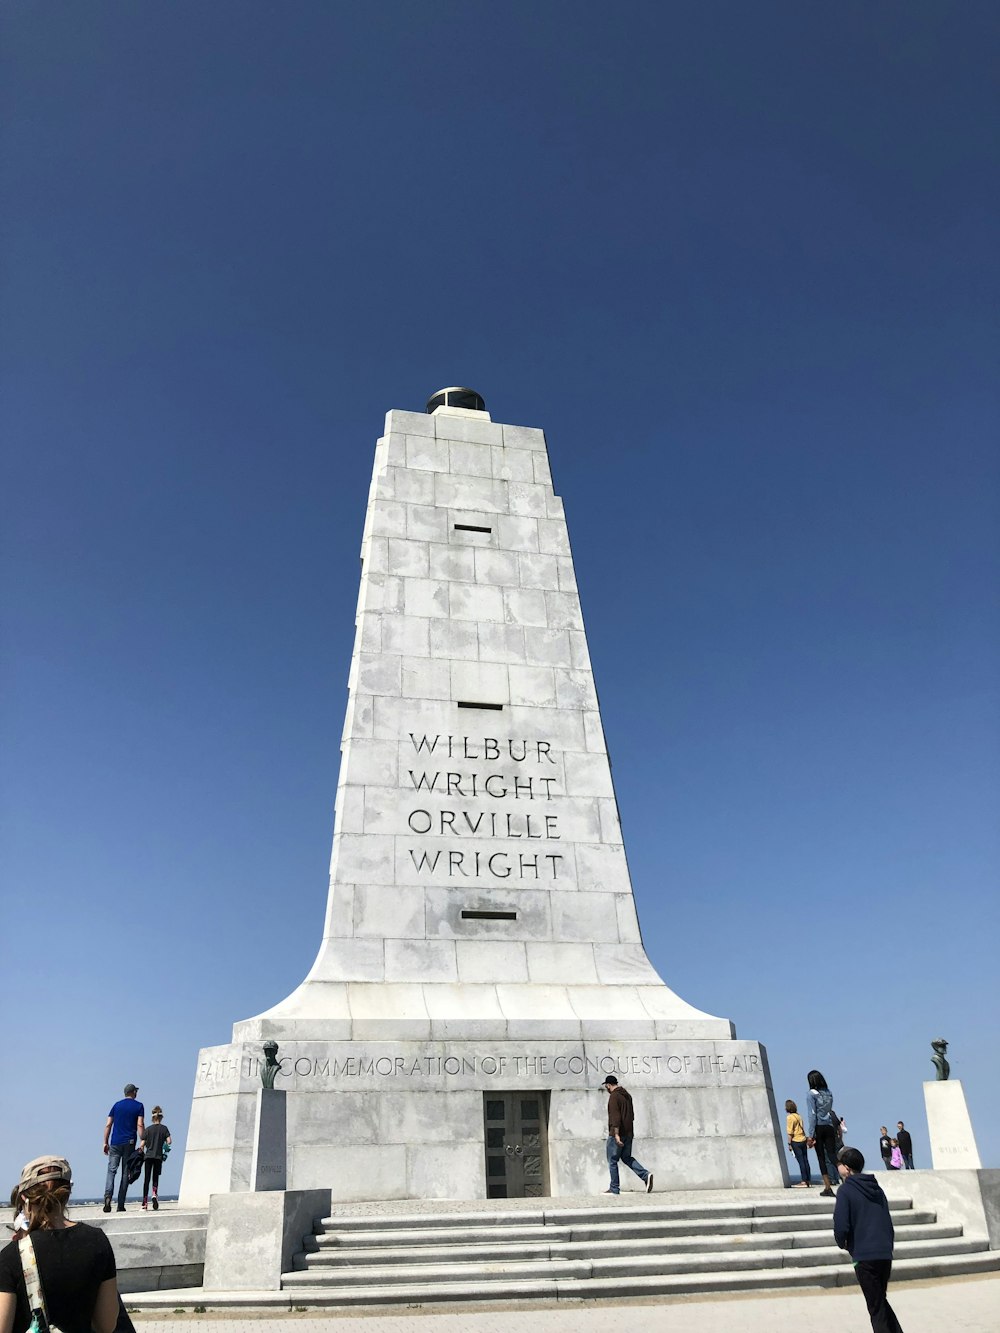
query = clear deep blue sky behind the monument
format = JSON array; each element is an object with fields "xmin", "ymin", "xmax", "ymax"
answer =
[{"xmin": 0, "ymin": 0, "xmax": 1000, "ymax": 1193}]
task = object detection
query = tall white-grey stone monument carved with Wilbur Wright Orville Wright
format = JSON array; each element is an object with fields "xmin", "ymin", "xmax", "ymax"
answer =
[{"xmin": 180, "ymin": 389, "xmax": 787, "ymax": 1206}]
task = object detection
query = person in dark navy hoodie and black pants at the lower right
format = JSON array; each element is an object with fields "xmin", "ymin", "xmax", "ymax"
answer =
[{"xmin": 833, "ymin": 1148, "xmax": 903, "ymax": 1333}]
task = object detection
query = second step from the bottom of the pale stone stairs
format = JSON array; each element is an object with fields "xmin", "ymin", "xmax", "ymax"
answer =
[{"xmin": 281, "ymin": 1237, "xmax": 988, "ymax": 1288}]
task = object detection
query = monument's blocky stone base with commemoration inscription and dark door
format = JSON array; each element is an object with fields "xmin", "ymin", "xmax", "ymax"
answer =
[{"xmin": 180, "ymin": 1025, "xmax": 788, "ymax": 1206}]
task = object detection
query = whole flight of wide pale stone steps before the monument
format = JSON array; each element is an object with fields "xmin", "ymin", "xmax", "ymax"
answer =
[{"xmin": 281, "ymin": 1196, "xmax": 1000, "ymax": 1306}]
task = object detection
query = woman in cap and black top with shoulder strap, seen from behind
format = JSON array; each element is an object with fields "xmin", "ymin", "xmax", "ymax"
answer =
[{"xmin": 0, "ymin": 1157, "xmax": 119, "ymax": 1333}]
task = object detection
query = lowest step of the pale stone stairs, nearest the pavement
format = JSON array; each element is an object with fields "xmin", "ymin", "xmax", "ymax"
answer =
[{"xmin": 276, "ymin": 1250, "xmax": 1000, "ymax": 1308}]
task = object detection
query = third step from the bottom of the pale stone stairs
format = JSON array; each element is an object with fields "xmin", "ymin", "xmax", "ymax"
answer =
[{"xmin": 295, "ymin": 1222, "xmax": 961, "ymax": 1270}]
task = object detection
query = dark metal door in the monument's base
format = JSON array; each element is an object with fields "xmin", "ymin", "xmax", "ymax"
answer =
[{"xmin": 483, "ymin": 1092, "xmax": 548, "ymax": 1198}]
